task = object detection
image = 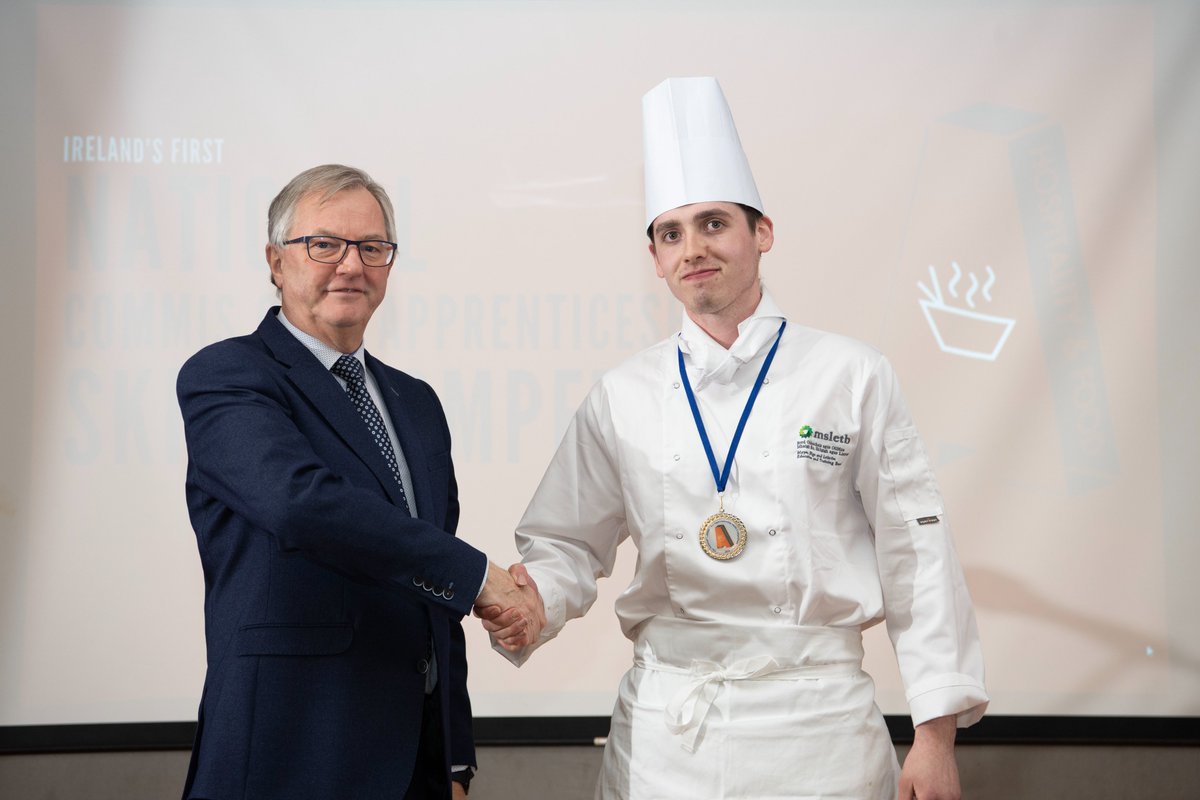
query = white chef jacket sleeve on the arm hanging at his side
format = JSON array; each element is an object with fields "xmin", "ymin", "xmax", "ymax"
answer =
[{"xmin": 856, "ymin": 356, "xmax": 988, "ymax": 727}]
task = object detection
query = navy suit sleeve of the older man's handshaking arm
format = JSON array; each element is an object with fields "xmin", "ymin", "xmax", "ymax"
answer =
[{"xmin": 176, "ymin": 342, "xmax": 487, "ymax": 615}]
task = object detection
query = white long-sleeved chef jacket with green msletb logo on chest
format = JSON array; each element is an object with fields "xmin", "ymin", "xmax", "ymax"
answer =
[{"xmin": 505, "ymin": 289, "xmax": 988, "ymax": 727}]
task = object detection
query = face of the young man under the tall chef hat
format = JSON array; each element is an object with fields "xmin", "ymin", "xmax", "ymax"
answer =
[{"xmin": 650, "ymin": 203, "xmax": 774, "ymax": 324}]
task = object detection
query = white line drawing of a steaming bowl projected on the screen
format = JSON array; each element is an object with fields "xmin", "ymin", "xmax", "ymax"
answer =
[{"xmin": 917, "ymin": 261, "xmax": 1016, "ymax": 361}]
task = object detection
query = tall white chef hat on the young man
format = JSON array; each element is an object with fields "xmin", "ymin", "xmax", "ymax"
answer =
[{"xmin": 642, "ymin": 78, "xmax": 763, "ymax": 228}]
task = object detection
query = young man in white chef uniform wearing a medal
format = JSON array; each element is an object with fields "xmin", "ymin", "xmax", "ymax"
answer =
[{"xmin": 485, "ymin": 78, "xmax": 988, "ymax": 800}]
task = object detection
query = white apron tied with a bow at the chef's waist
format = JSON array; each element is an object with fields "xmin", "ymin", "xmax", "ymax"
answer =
[{"xmin": 595, "ymin": 618, "xmax": 900, "ymax": 800}]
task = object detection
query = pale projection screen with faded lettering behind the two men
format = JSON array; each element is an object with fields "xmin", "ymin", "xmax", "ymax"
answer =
[{"xmin": 0, "ymin": 0, "xmax": 1200, "ymax": 726}]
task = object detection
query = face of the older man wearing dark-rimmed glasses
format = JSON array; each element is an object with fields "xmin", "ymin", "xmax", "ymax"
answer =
[{"xmin": 266, "ymin": 186, "xmax": 391, "ymax": 353}]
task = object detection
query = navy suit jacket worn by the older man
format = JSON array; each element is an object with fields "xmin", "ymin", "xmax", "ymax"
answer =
[{"xmin": 176, "ymin": 308, "xmax": 487, "ymax": 800}]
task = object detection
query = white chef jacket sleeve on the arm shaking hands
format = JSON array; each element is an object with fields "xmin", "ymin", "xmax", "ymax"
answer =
[{"xmin": 492, "ymin": 384, "xmax": 629, "ymax": 667}]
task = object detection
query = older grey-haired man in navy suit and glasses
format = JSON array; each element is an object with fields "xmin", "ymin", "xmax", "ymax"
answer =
[{"xmin": 178, "ymin": 164, "xmax": 544, "ymax": 800}]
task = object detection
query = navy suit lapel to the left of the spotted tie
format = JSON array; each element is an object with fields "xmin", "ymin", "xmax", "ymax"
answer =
[{"xmin": 258, "ymin": 308, "xmax": 412, "ymax": 505}]
